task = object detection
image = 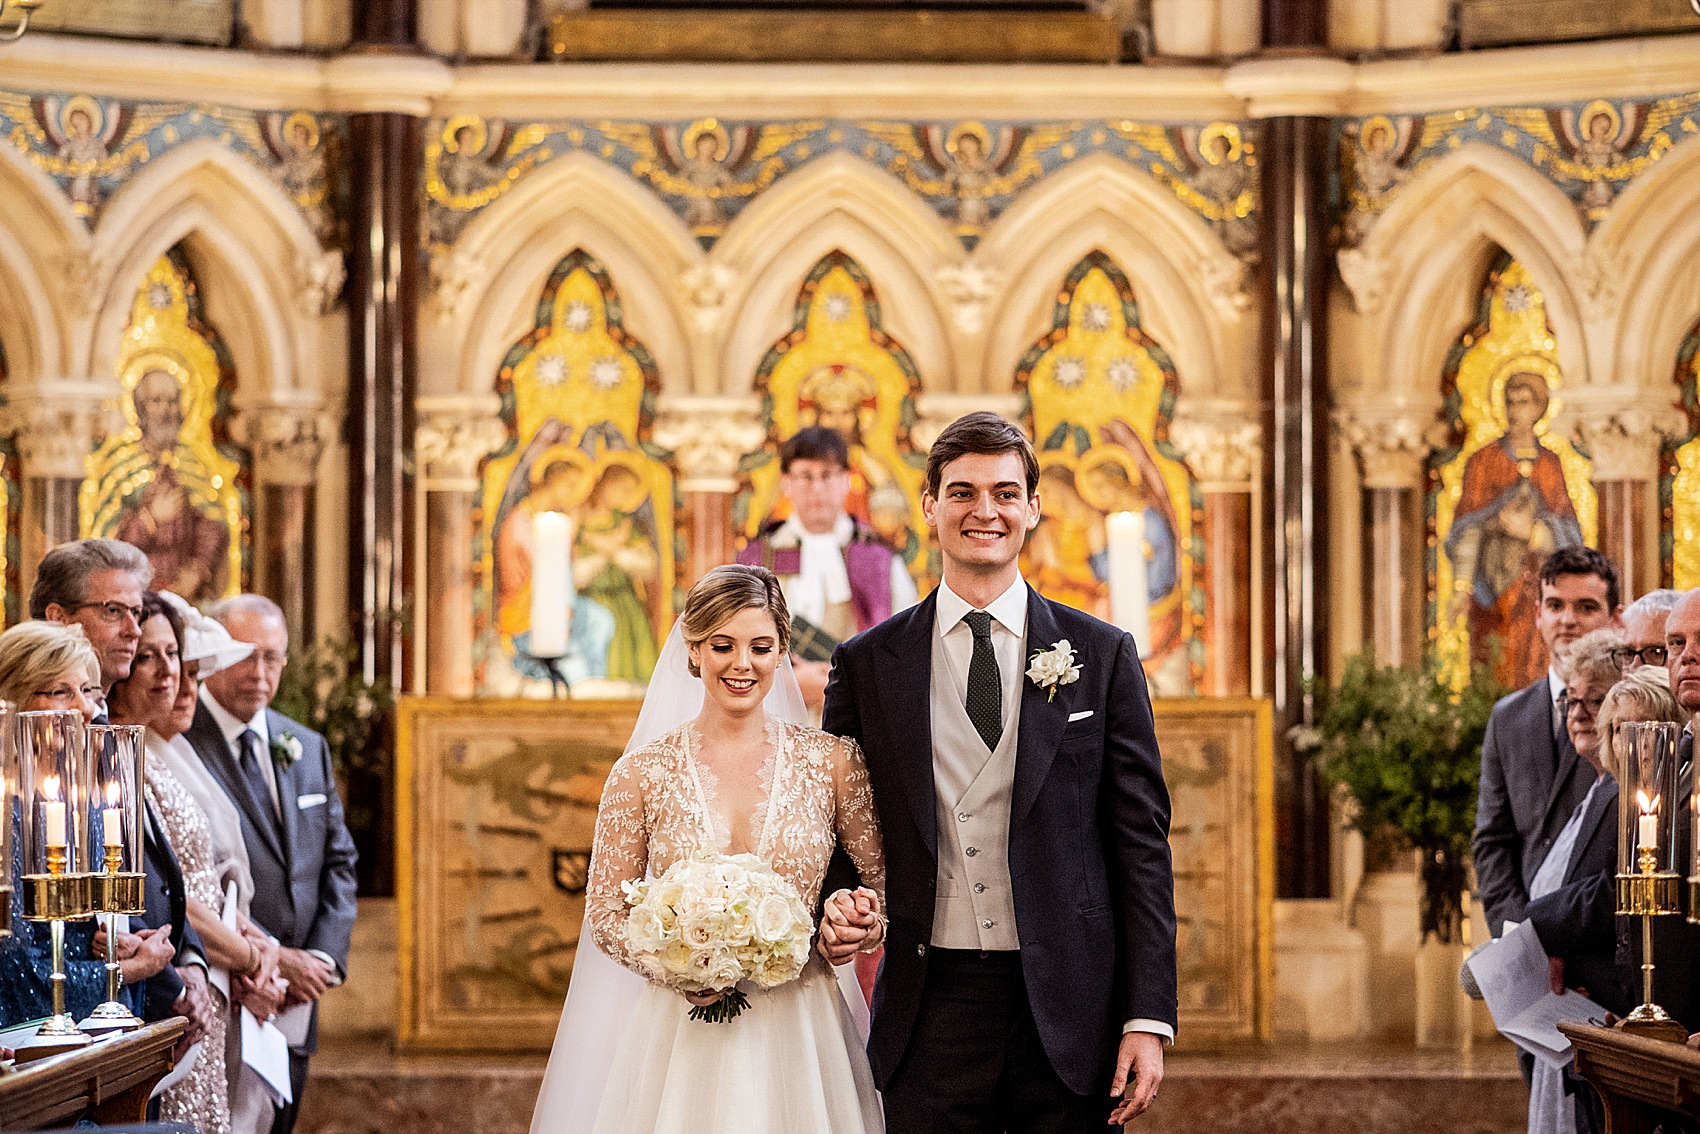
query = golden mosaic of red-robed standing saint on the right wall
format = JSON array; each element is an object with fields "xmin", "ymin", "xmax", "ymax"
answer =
[{"xmin": 1430, "ymin": 253, "xmax": 1596, "ymax": 689}]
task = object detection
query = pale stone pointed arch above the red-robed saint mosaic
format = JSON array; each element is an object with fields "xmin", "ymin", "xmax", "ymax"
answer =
[{"xmin": 1341, "ymin": 145, "xmax": 1595, "ymax": 408}]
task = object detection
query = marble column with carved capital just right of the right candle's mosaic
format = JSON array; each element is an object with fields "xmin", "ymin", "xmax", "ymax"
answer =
[{"xmin": 1170, "ymin": 410, "xmax": 1263, "ymax": 697}]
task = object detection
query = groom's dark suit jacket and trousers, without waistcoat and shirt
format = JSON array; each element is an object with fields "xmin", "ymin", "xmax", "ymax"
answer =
[{"xmin": 823, "ymin": 588, "xmax": 1176, "ymax": 1134}]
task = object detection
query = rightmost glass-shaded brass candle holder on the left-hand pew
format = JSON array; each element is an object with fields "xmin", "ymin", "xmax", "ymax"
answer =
[{"xmin": 78, "ymin": 724, "xmax": 146, "ymax": 1034}]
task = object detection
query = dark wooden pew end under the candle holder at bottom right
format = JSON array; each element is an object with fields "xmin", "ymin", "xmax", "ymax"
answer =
[{"xmin": 1559, "ymin": 1023, "xmax": 1700, "ymax": 1134}]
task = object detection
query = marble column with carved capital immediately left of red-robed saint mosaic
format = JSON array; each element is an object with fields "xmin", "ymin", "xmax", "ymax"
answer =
[{"xmin": 1336, "ymin": 411, "xmax": 1428, "ymax": 666}]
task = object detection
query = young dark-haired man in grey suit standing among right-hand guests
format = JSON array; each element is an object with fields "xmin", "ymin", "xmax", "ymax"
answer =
[{"xmin": 1471, "ymin": 547, "xmax": 1618, "ymax": 937}]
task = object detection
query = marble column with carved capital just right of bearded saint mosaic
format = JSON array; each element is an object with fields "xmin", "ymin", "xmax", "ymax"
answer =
[{"xmin": 236, "ymin": 405, "xmax": 330, "ymax": 646}]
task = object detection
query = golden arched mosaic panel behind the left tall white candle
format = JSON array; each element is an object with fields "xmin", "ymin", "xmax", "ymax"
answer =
[{"xmin": 478, "ymin": 252, "xmax": 678, "ymax": 695}]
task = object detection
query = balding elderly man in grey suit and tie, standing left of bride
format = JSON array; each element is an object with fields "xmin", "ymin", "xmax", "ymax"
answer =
[{"xmin": 187, "ymin": 595, "xmax": 355, "ymax": 1134}]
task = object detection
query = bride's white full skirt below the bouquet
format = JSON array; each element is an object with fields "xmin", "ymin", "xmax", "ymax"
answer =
[{"xmin": 592, "ymin": 957, "xmax": 886, "ymax": 1134}]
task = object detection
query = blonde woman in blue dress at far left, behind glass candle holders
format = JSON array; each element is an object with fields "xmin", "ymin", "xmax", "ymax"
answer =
[{"xmin": 0, "ymin": 622, "xmax": 173, "ymax": 1027}]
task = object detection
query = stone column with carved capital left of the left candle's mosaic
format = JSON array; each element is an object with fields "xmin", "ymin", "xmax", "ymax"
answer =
[{"xmin": 413, "ymin": 394, "xmax": 507, "ymax": 697}]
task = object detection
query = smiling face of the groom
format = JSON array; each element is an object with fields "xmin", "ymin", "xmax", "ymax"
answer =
[{"xmin": 921, "ymin": 452, "xmax": 1039, "ymax": 575}]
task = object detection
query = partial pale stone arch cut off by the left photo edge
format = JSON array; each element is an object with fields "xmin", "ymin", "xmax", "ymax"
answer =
[{"xmin": 0, "ymin": 146, "xmax": 92, "ymax": 384}]
